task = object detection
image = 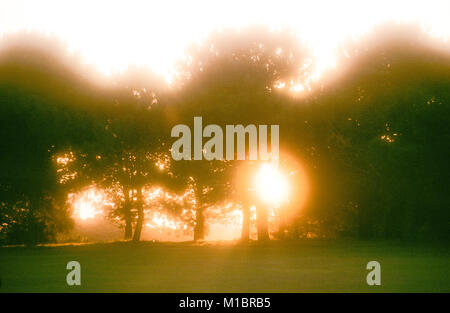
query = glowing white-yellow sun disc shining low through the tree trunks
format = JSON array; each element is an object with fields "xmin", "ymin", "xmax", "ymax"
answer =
[{"xmin": 254, "ymin": 163, "xmax": 290, "ymax": 206}]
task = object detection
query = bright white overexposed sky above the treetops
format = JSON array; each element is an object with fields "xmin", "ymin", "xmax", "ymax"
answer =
[{"xmin": 0, "ymin": 0, "xmax": 450, "ymax": 77}]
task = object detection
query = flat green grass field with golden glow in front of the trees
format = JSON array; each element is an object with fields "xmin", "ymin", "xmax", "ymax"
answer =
[{"xmin": 0, "ymin": 241, "xmax": 450, "ymax": 292}]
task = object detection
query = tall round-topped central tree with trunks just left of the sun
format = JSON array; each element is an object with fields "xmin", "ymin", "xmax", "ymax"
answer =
[{"xmin": 171, "ymin": 27, "xmax": 311, "ymax": 240}]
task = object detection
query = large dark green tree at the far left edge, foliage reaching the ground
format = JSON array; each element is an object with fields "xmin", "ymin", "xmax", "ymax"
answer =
[{"xmin": 0, "ymin": 35, "xmax": 106, "ymax": 243}]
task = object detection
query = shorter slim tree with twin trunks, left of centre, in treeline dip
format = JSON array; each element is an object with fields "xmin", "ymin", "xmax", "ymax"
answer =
[{"xmin": 96, "ymin": 76, "xmax": 167, "ymax": 241}]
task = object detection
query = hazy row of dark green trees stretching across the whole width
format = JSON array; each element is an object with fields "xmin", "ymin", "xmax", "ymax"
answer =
[{"xmin": 0, "ymin": 26, "xmax": 450, "ymax": 243}]
